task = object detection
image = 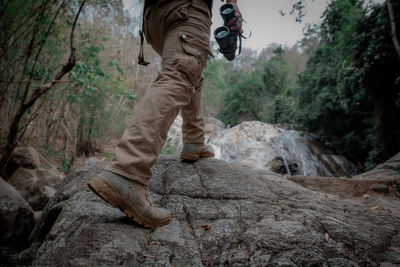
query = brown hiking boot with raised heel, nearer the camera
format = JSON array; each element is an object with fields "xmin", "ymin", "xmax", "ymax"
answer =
[{"xmin": 88, "ymin": 171, "xmax": 171, "ymax": 228}]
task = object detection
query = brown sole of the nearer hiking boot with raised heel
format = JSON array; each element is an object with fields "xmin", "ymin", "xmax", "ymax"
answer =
[{"xmin": 88, "ymin": 176, "xmax": 171, "ymax": 229}]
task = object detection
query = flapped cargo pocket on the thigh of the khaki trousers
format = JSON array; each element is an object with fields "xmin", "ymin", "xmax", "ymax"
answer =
[{"xmin": 174, "ymin": 33, "xmax": 211, "ymax": 88}]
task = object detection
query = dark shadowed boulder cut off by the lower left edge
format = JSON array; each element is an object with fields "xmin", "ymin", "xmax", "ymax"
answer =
[{"xmin": 0, "ymin": 178, "xmax": 35, "ymax": 249}]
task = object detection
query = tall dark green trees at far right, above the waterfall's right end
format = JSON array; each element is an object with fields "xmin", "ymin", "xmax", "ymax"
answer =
[{"xmin": 298, "ymin": 0, "xmax": 400, "ymax": 168}]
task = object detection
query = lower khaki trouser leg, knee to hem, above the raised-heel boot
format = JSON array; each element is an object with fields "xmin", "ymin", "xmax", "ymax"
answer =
[{"xmin": 106, "ymin": 64, "xmax": 192, "ymax": 185}]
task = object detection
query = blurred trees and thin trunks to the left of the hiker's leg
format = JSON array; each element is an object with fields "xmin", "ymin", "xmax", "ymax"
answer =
[{"xmin": 0, "ymin": 0, "xmax": 158, "ymax": 175}]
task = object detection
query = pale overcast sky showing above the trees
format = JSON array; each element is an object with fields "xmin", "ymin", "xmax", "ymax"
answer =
[{"xmin": 123, "ymin": 0, "xmax": 384, "ymax": 51}]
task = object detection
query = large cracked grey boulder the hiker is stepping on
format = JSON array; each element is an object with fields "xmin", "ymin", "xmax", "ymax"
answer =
[{"xmin": 20, "ymin": 157, "xmax": 400, "ymax": 266}]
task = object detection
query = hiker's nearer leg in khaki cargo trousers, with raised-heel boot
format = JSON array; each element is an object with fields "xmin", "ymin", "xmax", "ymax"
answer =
[{"xmin": 89, "ymin": 0, "xmax": 211, "ymax": 227}]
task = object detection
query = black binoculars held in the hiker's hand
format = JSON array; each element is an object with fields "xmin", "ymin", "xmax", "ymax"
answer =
[{"xmin": 214, "ymin": 4, "xmax": 240, "ymax": 61}]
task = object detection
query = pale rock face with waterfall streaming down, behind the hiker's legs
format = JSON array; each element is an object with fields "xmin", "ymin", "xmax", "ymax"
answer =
[{"xmin": 163, "ymin": 116, "xmax": 357, "ymax": 177}]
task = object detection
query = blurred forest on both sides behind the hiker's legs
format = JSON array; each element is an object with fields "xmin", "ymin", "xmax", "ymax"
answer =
[{"xmin": 0, "ymin": 0, "xmax": 400, "ymax": 176}]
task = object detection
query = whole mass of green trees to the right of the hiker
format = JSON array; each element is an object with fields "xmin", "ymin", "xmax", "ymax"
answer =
[{"xmin": 212, "ymin": 0, "xmax": 400, "ymax": 169}]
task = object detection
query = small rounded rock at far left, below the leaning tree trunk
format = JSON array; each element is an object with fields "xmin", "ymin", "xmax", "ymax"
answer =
[{"xmin": 7, "ymin": 146, "xmax": 40, "ymax": 177}]
